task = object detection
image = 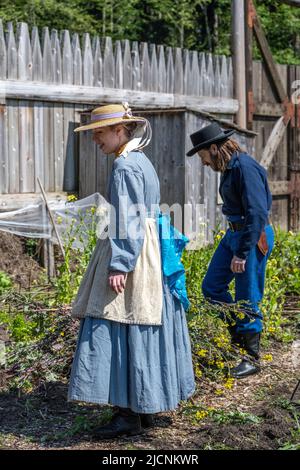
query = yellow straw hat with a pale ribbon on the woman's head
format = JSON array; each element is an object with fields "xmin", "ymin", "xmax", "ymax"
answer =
[{"xmin": 75, "ymin": 103, "xmax": 147, "ymax": 132}]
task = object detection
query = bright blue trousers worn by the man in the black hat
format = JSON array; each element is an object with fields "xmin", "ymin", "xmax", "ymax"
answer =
[{"xmin": 202, "ymin": 225, "xmax": 274, "ymax": 333}]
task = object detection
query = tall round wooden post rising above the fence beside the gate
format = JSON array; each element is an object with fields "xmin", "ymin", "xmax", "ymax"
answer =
[{"xmin": 231, "ymin": 0, "xmax": 247, "ymax": 128}]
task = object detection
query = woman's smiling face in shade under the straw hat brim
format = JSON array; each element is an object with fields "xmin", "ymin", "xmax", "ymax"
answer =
[{"xmin": 93, "ymin": 126, "xmax": 128, "ymax": 154}]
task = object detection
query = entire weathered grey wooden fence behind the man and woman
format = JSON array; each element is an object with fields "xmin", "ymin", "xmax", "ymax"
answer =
[{"xmin": 0, "ymin": 21, "xmax": 298, "ymax": 239}]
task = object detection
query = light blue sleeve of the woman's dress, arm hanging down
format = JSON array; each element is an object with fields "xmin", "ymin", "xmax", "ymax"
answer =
[{"xmin": 109, "ymin": 169, "xmax": 145, "ymax": 272}]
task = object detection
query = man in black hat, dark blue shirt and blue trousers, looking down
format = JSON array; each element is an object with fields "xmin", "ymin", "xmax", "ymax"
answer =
[{"xmin": 187, "ymin": 123, "xmax": 274, "ymax": 378}]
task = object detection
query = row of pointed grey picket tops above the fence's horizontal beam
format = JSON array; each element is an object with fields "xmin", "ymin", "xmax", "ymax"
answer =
[{"xmin": 0, "ymin": 20, "xmax": 233, "ymax": 97}]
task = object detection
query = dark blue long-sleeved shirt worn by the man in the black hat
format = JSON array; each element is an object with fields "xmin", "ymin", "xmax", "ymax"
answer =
[{"xmin": 219, "ymin": 153, "xmax": 272, "ymax": 259}]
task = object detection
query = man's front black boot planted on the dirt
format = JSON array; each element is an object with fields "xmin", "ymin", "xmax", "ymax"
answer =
[{"xmin": 230, "ymin": 333, "xmax": 260, "ymax": 379}]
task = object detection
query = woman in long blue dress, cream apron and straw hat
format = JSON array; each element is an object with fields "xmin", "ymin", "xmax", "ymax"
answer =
[{"xmin": 68, "ymin": 103, "xmax": 195, "ymax": 439}]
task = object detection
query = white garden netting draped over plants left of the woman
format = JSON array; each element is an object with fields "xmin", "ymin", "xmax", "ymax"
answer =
[{"xmin": 0, "ymin": 193, "xmax": 109, "ymax": 249}]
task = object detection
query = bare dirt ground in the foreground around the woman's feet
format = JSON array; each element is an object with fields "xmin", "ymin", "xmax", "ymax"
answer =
[{"xmin": 0, "ymin": 345, "xmax": 299, "ymax": 450}]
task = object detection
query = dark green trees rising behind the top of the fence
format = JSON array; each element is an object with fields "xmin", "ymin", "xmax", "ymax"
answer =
[{"xmin": 0, "ymin": 0, "xmax": 300, "ymax": 64}]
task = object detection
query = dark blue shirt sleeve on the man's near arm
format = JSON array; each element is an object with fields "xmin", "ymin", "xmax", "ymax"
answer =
[{"xmin": 234, "ymin": 165, "xmax": 268, "ymax": 259}]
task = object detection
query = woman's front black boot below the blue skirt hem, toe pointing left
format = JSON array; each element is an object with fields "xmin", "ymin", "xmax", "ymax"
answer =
[{"xmin": 92, "ymin": 408, "xmax": 143, "ymax": 439}]
